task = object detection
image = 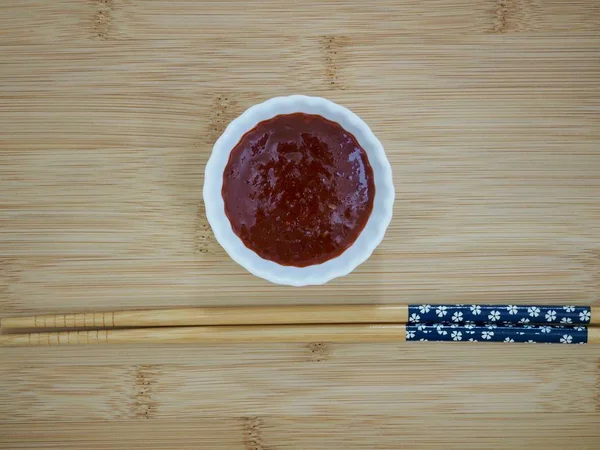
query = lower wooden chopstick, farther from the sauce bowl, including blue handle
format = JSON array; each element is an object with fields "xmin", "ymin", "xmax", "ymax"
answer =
[{"xmin": 0, "ymin": 324, "xmax": 600, "ymax": 346}]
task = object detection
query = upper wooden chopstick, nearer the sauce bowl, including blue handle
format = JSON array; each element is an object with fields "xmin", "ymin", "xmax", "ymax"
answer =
[{"xmin": 1, "ymin": 304, "xmax": 600, "ymax": 331}]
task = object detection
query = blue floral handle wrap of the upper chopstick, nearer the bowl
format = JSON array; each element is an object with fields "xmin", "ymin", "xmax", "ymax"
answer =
[{"xmin": 408, "ymin": 305, "xmax": 591, "ymax": 325}]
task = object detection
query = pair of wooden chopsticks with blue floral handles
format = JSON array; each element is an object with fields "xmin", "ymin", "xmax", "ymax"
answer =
[{"xmin": 0, "ymin": 305, "xmax": 600, "ymax": 346}]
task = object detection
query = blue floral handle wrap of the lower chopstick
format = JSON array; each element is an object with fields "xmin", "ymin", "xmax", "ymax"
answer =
[{"xmin": 406, "ymin": 324, "xmax": 587, "ymax": 344}]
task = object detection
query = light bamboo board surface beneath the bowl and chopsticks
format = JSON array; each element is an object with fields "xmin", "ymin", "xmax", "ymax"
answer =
[{"xmin": 0, "ymin": 0, "xmax": 600, "ymax": 450}]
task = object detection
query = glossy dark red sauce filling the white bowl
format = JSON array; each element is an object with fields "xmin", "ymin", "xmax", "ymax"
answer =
[{"xmin": 222, "ymin": 113, "xmax": 375, "ymax": 267}]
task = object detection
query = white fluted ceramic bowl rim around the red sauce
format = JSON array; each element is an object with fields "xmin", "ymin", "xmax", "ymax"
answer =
[{"xmin": 204, "ymin": 95, "xmax": 394, "ymax": 286}]
